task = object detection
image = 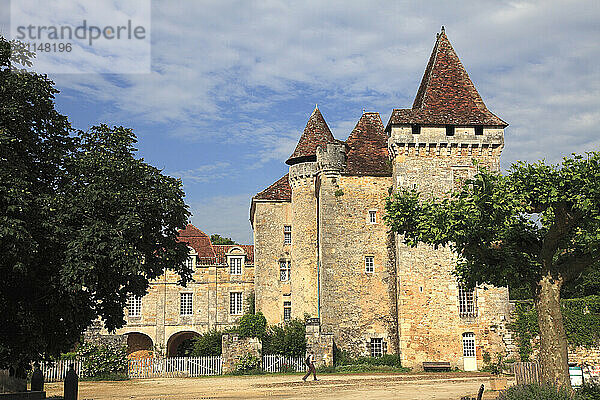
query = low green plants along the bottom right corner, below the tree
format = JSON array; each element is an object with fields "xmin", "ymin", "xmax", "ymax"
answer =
[{"xmin": 498, "ymin": 384, "xmax": 600, "ymax": 400}]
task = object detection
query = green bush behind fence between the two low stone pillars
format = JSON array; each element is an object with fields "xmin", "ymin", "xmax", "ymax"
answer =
[{"xmin": 262, "ymin": 319, "xmax": 306, "ymax": 357}]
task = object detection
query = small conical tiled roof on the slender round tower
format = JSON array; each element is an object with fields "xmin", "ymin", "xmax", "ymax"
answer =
[{"xmin": 285, "ymin": 106, "xmax": 335, "ymax": 165}]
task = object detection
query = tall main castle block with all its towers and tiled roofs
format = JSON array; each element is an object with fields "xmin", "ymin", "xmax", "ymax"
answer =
[{"xmin": 250, "ymin": 29, "xmax": 509, "ymax": 370}]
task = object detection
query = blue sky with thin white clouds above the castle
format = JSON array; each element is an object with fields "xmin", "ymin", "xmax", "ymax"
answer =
[{"xmin": 0, "ymin": 0, "xmax": 600, "ymax": 243}]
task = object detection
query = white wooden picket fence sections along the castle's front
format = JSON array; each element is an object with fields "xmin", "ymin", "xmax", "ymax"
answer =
[{"xmin": 41, "ymin": 354, "xmax": 305, "ymax": 382}]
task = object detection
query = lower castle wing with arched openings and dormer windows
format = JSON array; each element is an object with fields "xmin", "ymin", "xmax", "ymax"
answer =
[{"xmin": 115, "ymin": 225, "xmax": 254, "ymax": 356}]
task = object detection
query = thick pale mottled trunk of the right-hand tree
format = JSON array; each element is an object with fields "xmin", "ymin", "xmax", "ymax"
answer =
[{"xmin": 535, "ymin": 271, "xmax": 571, "ymax": 388}]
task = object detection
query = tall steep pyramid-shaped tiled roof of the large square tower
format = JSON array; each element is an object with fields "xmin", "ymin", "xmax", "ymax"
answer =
[{"xmin": 388, "ymin": 28, "xmax": 508, "ymax": 128}]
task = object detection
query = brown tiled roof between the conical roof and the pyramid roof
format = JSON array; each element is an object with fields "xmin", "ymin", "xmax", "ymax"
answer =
[{"xmin": 345, "ymin": 112, "xmax": 392, "ymax": 176}]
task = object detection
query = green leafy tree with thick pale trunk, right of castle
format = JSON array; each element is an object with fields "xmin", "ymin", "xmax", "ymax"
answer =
[{"xmin": 385, "ymin": 152, "xmax": 600, "ymax": 386}]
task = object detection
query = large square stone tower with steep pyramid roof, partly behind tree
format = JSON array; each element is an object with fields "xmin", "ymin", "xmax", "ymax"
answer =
[{"xmin": 386, "ymin": 28, "xmax": 508, "ymax": 370}]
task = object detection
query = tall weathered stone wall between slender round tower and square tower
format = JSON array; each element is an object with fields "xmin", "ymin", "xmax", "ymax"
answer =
[{"xmin": 319, "ymin": 174, "xmax": 398, "ymax": 356}]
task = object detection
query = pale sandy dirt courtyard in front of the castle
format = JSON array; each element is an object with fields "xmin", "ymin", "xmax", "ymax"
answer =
[{"xmin": 45, "ymin": 373, "xmax": 502, "ymax": 400}]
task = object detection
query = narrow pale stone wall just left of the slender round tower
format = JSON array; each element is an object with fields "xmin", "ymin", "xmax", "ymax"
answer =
[{"xmin": 252, "ymin": 201, "xmax": 297, "ymax": 324}]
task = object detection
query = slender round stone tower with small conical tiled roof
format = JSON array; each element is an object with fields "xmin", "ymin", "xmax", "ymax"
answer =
[{"xmin": 286, "ymin": 107, "xmax": 335, "ymax": 318}]
